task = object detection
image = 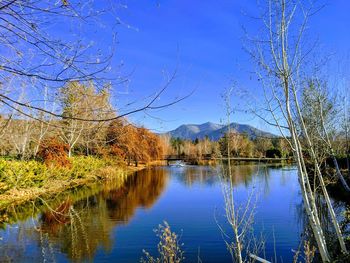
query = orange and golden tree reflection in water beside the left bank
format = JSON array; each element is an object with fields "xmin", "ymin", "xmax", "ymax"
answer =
[{"xmin": 42, "ymin": 169, "xmax": 167, "ymax": 261}]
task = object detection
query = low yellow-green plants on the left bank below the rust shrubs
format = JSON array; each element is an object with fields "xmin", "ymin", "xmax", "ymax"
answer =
[{"xmin": 0, "ymin": 157, "xmax": 144, "ymax": 211}]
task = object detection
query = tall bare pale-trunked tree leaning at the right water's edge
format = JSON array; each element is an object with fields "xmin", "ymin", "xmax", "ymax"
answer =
[{"xmin": 246, "ymin": 0, "xmax": 347, "ymax": 262}]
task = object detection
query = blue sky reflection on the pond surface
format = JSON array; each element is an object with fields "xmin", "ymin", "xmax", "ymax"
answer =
[{"xmin": 0, "ymin": 165, "xmax": 302, "ymax": 262}]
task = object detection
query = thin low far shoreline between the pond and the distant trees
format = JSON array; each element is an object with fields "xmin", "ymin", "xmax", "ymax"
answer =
[{"xmin": 163, "ymin": 154, "xmax": 293, "ymax": 163}]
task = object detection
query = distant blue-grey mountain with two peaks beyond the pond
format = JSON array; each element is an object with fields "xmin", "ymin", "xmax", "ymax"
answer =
[{"xmin": 167, "ymin": 122, "xmax": 277, "ymax": 141}]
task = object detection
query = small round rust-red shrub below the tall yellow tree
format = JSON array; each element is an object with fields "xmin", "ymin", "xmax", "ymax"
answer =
[{"xmin": 38, "ymin": 137, "xmax": 71, "ymax": 167}]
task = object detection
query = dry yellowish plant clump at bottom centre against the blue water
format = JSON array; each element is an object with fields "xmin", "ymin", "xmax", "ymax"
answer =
[{"xmin": 140, "ymin": 221, "xmax": 185, "ymax": 263}]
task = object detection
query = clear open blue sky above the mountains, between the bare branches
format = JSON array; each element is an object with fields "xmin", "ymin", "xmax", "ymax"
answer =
[{"xmin": 93, "ymin": 0, "xmax": 350, "ymax": 134}]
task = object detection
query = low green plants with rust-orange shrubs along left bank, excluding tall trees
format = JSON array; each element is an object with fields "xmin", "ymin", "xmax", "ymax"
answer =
[{"xmin": 0, "ymin": 121, "xmax": 166, "ymax": 209}]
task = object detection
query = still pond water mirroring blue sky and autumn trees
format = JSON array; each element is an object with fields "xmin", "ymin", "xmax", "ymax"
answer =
[{"xmin": 0, "ymin": 165, "xmax": 303, "ymax": 262}]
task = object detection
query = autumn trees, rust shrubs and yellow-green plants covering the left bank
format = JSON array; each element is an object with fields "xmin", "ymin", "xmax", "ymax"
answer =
[{"xmin": 0, "ymin": 82, "xmax": 164, "ymax": 206}]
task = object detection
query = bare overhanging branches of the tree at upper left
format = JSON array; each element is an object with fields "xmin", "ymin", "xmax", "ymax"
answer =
[{"xmin": 0, "ymin": 0, "xmax": 187, "ymax": 127}]
